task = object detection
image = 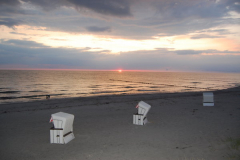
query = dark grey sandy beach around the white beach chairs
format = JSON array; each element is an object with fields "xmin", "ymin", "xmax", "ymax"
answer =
[{"xmin": 0, "ymin": 87, "xmax": 240, "ymax": 160}]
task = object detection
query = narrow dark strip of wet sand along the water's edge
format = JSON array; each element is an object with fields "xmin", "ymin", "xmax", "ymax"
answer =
[{"xmin": 0, "ymin": 86, "xmax": 240, "ymax": 114}]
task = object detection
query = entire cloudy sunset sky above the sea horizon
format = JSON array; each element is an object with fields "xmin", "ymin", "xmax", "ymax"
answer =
[{"xmin": 0, "ymin": 0, "xmax": 240, "ymax": 73}]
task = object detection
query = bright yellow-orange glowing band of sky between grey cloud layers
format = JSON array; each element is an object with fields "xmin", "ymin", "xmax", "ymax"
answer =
[{"xmin": 0, "ymin": 25, "xmax": 240, "ymax": 54}]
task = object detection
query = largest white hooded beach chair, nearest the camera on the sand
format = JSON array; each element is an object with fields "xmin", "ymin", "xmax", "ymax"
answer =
[{"xmin": 50, "ymin": 112, "xmax": 75, "ymax": 144}]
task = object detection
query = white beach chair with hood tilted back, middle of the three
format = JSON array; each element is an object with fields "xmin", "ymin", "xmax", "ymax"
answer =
[{"xmin": 133, "ymin": 101, "xmax": 151, "ymax": 125}]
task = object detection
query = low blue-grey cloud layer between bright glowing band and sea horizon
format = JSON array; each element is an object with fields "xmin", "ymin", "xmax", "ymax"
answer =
[{"xmin": 0, "ymin": 40, "xmax": 240, "ymax": 72}]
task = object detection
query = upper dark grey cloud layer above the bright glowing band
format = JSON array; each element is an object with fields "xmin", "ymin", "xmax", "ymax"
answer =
[{"xmin": 0, "ymin": 0, "xmax": 240, "ymax": 39}]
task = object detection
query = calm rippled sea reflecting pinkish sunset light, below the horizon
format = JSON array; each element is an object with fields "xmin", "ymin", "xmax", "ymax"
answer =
[{"xmin": 0, "ymin": 70, "xmax": 240, "ymax": 104}]
